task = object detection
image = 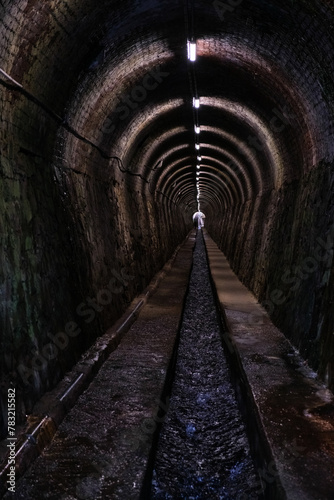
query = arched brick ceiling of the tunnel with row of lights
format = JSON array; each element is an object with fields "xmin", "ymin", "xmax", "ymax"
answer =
[{"xmin": 2, "ymin": 0, "xmax": 334, "ymax": 212}]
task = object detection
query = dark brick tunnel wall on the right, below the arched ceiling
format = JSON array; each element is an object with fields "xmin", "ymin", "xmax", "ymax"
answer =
[{"xmin": 206, "ymin": 162, "xmax": 334, "ymax": 390}]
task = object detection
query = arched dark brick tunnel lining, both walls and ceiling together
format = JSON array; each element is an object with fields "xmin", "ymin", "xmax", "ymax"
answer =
[{"xmin": 0, "ymin": 0, "xmax": 334, "ymax": 496}]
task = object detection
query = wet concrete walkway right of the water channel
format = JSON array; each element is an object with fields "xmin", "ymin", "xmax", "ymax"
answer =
[{"xmin": 204, "ymin": 230, "xmax": 334, "ymax": 500}]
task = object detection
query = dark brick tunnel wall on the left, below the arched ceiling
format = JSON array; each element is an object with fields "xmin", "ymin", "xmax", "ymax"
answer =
[{"xmin": 0, "ymin": 77, "xmax": 189, "ymax": 435}]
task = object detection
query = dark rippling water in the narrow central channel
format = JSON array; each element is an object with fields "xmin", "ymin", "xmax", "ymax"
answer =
[{"xmin": 150, "ymin": 231, "xmax": 262, "ymax": 500}]
